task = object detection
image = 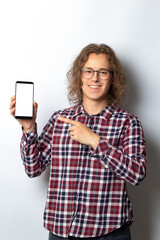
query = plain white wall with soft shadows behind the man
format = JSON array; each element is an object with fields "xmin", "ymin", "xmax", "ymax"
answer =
[{"xmin": 0, "ymin": 0, "xmax": 160, "ymax": 240}]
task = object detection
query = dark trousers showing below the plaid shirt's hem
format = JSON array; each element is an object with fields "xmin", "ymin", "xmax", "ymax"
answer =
[{"xmin": 49, "ymin": 224, "xmax": 131, "ymax": 240}]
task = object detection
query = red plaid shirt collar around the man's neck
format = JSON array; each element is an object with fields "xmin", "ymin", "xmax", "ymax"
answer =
[{"xmin": 73, "ymin": 103, "xmax": 117, "ymax": 120}]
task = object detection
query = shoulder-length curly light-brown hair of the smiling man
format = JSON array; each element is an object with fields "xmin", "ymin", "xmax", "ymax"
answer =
[{"xmin": 67, "ymin": 43, "xmax": 126, "ymax": 105}]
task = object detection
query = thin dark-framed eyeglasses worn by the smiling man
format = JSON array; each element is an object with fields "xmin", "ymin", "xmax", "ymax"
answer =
[{"xmin": 81, "ymin": 68, "xmax": 113, "ymax": 81}]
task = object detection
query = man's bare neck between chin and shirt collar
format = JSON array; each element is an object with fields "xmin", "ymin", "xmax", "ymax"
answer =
[{"xmin": 83, "ymin": 101, "xmax": 108, "ymax": 115}]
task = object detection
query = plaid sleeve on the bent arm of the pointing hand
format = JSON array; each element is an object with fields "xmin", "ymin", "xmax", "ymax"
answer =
[{"xmin": 90, "ymin": 118, "xmax": 146, "ymax": 185}]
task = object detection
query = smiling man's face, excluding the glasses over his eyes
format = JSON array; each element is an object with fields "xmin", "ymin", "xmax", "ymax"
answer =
[{"xmin": 81, "ymin": 53, "xmax": 112, "ymax": 104}]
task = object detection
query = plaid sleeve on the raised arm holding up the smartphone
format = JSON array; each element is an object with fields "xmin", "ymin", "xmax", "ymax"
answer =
[{"xmin": 20, "ymin": 113, "xmax": 54, "ymax": 177}]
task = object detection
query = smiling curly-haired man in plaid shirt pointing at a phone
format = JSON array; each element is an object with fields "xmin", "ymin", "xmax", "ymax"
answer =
[{"xmin": 10, "ymin": 44, "xmax": 146, "ymax": 240}]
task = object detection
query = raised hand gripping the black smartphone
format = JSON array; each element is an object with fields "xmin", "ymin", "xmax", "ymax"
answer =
[{"xmin": 9, "ymin": 96, "xmax": 38, "ymax": 132}]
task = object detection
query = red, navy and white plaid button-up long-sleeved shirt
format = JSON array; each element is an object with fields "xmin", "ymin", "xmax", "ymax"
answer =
[{"xmin": 21, "ymin": 105, "xmax": 146, "ymax": 237}]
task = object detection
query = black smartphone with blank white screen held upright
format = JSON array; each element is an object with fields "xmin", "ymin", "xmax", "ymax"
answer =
[{"xmin": 15, "ymin": 81, "xmax": 34, "ymax": 119}]
